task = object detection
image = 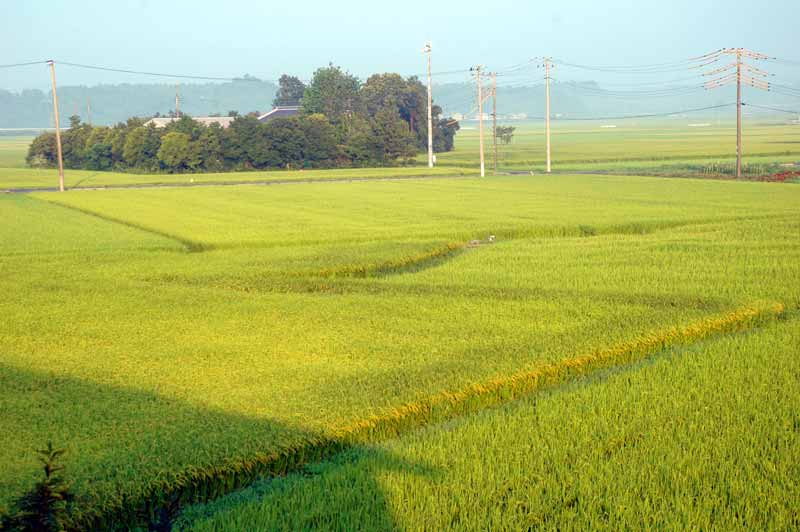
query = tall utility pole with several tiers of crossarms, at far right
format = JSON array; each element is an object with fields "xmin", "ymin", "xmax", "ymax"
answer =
[{"xmin": 703, "ymin": 48, "xmax": 770, "ymax": 178}]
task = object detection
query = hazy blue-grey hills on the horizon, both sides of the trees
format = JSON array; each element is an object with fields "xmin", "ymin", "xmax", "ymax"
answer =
[{"xmin": 0, "ymin": 78, "xmax": 800, "ymax": 129}]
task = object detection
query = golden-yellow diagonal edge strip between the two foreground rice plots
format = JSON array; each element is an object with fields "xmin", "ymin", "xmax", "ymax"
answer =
[{"xmin": 67, "ymin": 302, "xmax": 786, "ymax": 530}]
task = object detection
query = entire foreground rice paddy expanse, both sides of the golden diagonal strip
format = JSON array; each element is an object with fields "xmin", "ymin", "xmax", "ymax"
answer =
[{"xmin": 0, "ymin": 122, "xmax": 800, "ymax": 530}]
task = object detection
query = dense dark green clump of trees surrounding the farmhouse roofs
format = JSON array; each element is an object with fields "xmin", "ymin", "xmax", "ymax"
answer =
[{"xmin": 27, "ymin": 65, "xmax": 459, "ymax": 172}]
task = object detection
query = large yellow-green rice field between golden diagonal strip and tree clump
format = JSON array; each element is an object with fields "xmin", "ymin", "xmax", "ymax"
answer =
[{"xmin": 0, "ymin": 176, "xmax": 800, "ymax": 528}]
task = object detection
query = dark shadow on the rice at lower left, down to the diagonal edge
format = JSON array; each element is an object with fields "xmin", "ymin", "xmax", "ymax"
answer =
[{"xmin": 0, "ymin": 365, "xmax": 431, "ymax": 530}]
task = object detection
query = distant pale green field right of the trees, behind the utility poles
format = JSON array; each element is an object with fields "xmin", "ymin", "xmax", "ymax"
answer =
[{"xmin": 437, "ymin": 118, "xmax": 800, "ymax": 172}]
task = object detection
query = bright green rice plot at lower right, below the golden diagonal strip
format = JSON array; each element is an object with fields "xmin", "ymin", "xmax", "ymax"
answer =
[{"xmin": 180, "ymin": 317, "xmax": 800, "ymax": 532}]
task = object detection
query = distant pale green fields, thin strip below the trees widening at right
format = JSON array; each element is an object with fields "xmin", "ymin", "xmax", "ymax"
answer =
[{"xmin": 0, "ymin": 118, "xmax": 800, "ymax": 190}]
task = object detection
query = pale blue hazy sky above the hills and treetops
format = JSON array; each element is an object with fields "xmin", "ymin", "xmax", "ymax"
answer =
[{"xmin": 0, "ymin": 0, "xmax": 800, "ymax": 90}]
